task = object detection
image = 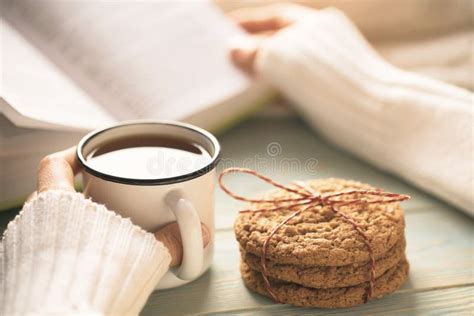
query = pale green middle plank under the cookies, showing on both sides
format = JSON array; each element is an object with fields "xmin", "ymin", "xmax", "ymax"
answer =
[{"xmin": 144, "ymin": 209, "xmax": 474, "ymax": 315}]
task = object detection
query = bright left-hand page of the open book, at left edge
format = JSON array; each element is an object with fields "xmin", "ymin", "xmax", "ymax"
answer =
[{"xmin": 0, "ymin": 20, "xmax": 115, "ymax": 130}]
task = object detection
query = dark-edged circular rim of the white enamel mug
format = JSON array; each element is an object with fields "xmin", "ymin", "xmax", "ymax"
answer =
[{"xmin": 76, "ymin": 120, "xmax": 221, "ymax": 185}]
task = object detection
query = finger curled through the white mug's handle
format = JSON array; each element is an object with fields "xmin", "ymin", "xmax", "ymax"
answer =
[{"xmin": 155, "ymin": 222, "xmax": 211, "ymax": 267}]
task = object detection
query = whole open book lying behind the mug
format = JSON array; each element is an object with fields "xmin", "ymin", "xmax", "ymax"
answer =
[{"xmin": 0, "ymin": 0, "xmax": 272, "ymax": 209}]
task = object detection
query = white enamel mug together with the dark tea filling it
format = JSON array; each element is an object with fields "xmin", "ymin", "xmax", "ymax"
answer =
[{"xmin": 77, "ymin": 120, "xmax": 220, "ymax": 289}]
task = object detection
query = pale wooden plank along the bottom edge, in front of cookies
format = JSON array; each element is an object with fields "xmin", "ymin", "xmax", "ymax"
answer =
[{"xmin": 206, "ymin": 286, "xmax": 474, "ymax": 316}]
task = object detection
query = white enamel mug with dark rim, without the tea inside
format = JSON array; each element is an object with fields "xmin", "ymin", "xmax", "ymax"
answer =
[{"xmin": 77, "ymin": 120, "xmax": 220, "ymax": 289}]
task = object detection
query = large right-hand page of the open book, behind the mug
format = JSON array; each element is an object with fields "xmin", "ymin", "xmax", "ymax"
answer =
[{"xmin": 4, "ymin": 0, "xmax": 254, "ymax": 126}]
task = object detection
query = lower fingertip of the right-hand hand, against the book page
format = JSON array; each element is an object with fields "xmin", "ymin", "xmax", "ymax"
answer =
[{"xmin": 230, "ymin": 36, "xmax": 262, "ymax": 75}]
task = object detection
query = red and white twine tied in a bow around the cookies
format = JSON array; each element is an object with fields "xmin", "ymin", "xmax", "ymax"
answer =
[{"xmin": 218, "ymin": 168, "xmax": 410, "ymax": 302}]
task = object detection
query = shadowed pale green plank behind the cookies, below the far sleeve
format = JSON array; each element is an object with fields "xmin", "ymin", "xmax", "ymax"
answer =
[{"xmin": 216, "ymin": 119, "xmax": 452, "ymax": 228}]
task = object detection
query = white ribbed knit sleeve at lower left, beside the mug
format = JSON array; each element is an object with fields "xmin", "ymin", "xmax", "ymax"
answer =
[{"xmin": 0, "ymin": 191, "xmax": 171, "ymax": 315}]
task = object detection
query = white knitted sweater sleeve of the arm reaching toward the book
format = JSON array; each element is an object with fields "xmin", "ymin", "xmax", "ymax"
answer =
[{"xmin": 256, "ymin": 9, "xmax": 474, "ymax": 214}]
